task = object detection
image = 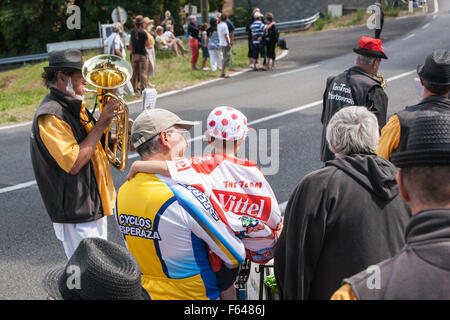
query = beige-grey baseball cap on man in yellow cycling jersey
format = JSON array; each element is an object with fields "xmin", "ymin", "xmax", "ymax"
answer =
[{"xmin": 131, "ymin": 108, "xmax": 199, "ymax": 148}]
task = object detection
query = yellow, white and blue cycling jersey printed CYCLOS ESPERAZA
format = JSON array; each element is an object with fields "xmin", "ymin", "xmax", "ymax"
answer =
[{"xmin": 116, "ymin": 173, "xmax": 245, "ymax": 300}]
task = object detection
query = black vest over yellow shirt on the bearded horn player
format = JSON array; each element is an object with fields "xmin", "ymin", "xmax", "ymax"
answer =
[{"xmin": 30, "ymin": 89, "xmax": 104, "ymax": 223}]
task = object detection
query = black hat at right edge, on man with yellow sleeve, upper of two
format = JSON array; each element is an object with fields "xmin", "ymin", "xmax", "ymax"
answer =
[{"xmin": 417, "ymin": 49, "xmax": 450, "ymax": 85}]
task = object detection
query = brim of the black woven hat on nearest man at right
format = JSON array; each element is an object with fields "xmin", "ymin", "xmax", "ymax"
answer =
[{"xmin": 391, "ymin": 149, "xmax": 450, "ymax": 168}]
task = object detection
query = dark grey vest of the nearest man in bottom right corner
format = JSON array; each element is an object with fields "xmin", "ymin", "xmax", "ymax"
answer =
[{"xmin": 344, "ymin": 208, "xmax": 450, "ymax": 300}]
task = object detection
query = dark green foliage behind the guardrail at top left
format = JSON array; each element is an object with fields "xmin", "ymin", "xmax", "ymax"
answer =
[{"xmin": 0, "ymin": 0, "xmax": 185, "ymax": 57}]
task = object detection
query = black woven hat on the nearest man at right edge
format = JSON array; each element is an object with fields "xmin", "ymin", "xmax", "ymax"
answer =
[{"xmin": 391, "ymin": 112, "xmax": 450, "ymax": 168}]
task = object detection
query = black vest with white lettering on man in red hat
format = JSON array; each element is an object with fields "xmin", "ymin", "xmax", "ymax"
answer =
[{"xmin": 320, "ymin": 66, "xmax": 388, "ymax": 162}]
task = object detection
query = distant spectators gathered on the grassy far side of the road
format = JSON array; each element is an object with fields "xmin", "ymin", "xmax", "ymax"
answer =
[{"xmin": 104, "ymin": 8, "xmax": 279, "ymax": 95}]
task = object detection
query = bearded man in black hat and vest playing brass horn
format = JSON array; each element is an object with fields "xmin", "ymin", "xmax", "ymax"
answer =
[{"xmin": 30, "ymin": 49, "xmax": 120, "ymax": 258}]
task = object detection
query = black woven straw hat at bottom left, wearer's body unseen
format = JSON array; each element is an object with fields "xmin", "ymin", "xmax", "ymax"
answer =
[{"xmin": 43, "ymin": 238, "xmax": 151, "ymax": 300}]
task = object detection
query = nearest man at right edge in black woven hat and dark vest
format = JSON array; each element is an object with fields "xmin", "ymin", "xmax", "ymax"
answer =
[{"xmin": 331, "ymin": 112, "xmax": 450, "ymax": 300}]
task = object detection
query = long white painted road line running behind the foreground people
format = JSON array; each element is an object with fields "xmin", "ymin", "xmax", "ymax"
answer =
[{"xmin": 0, "ymin": 70, "xmax": 416, "ymax": 194}]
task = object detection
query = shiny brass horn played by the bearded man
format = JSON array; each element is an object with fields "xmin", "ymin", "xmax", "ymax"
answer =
[{"xmin": 82, "ymin": 54, "xmax": 133, "ymax": 171}]
